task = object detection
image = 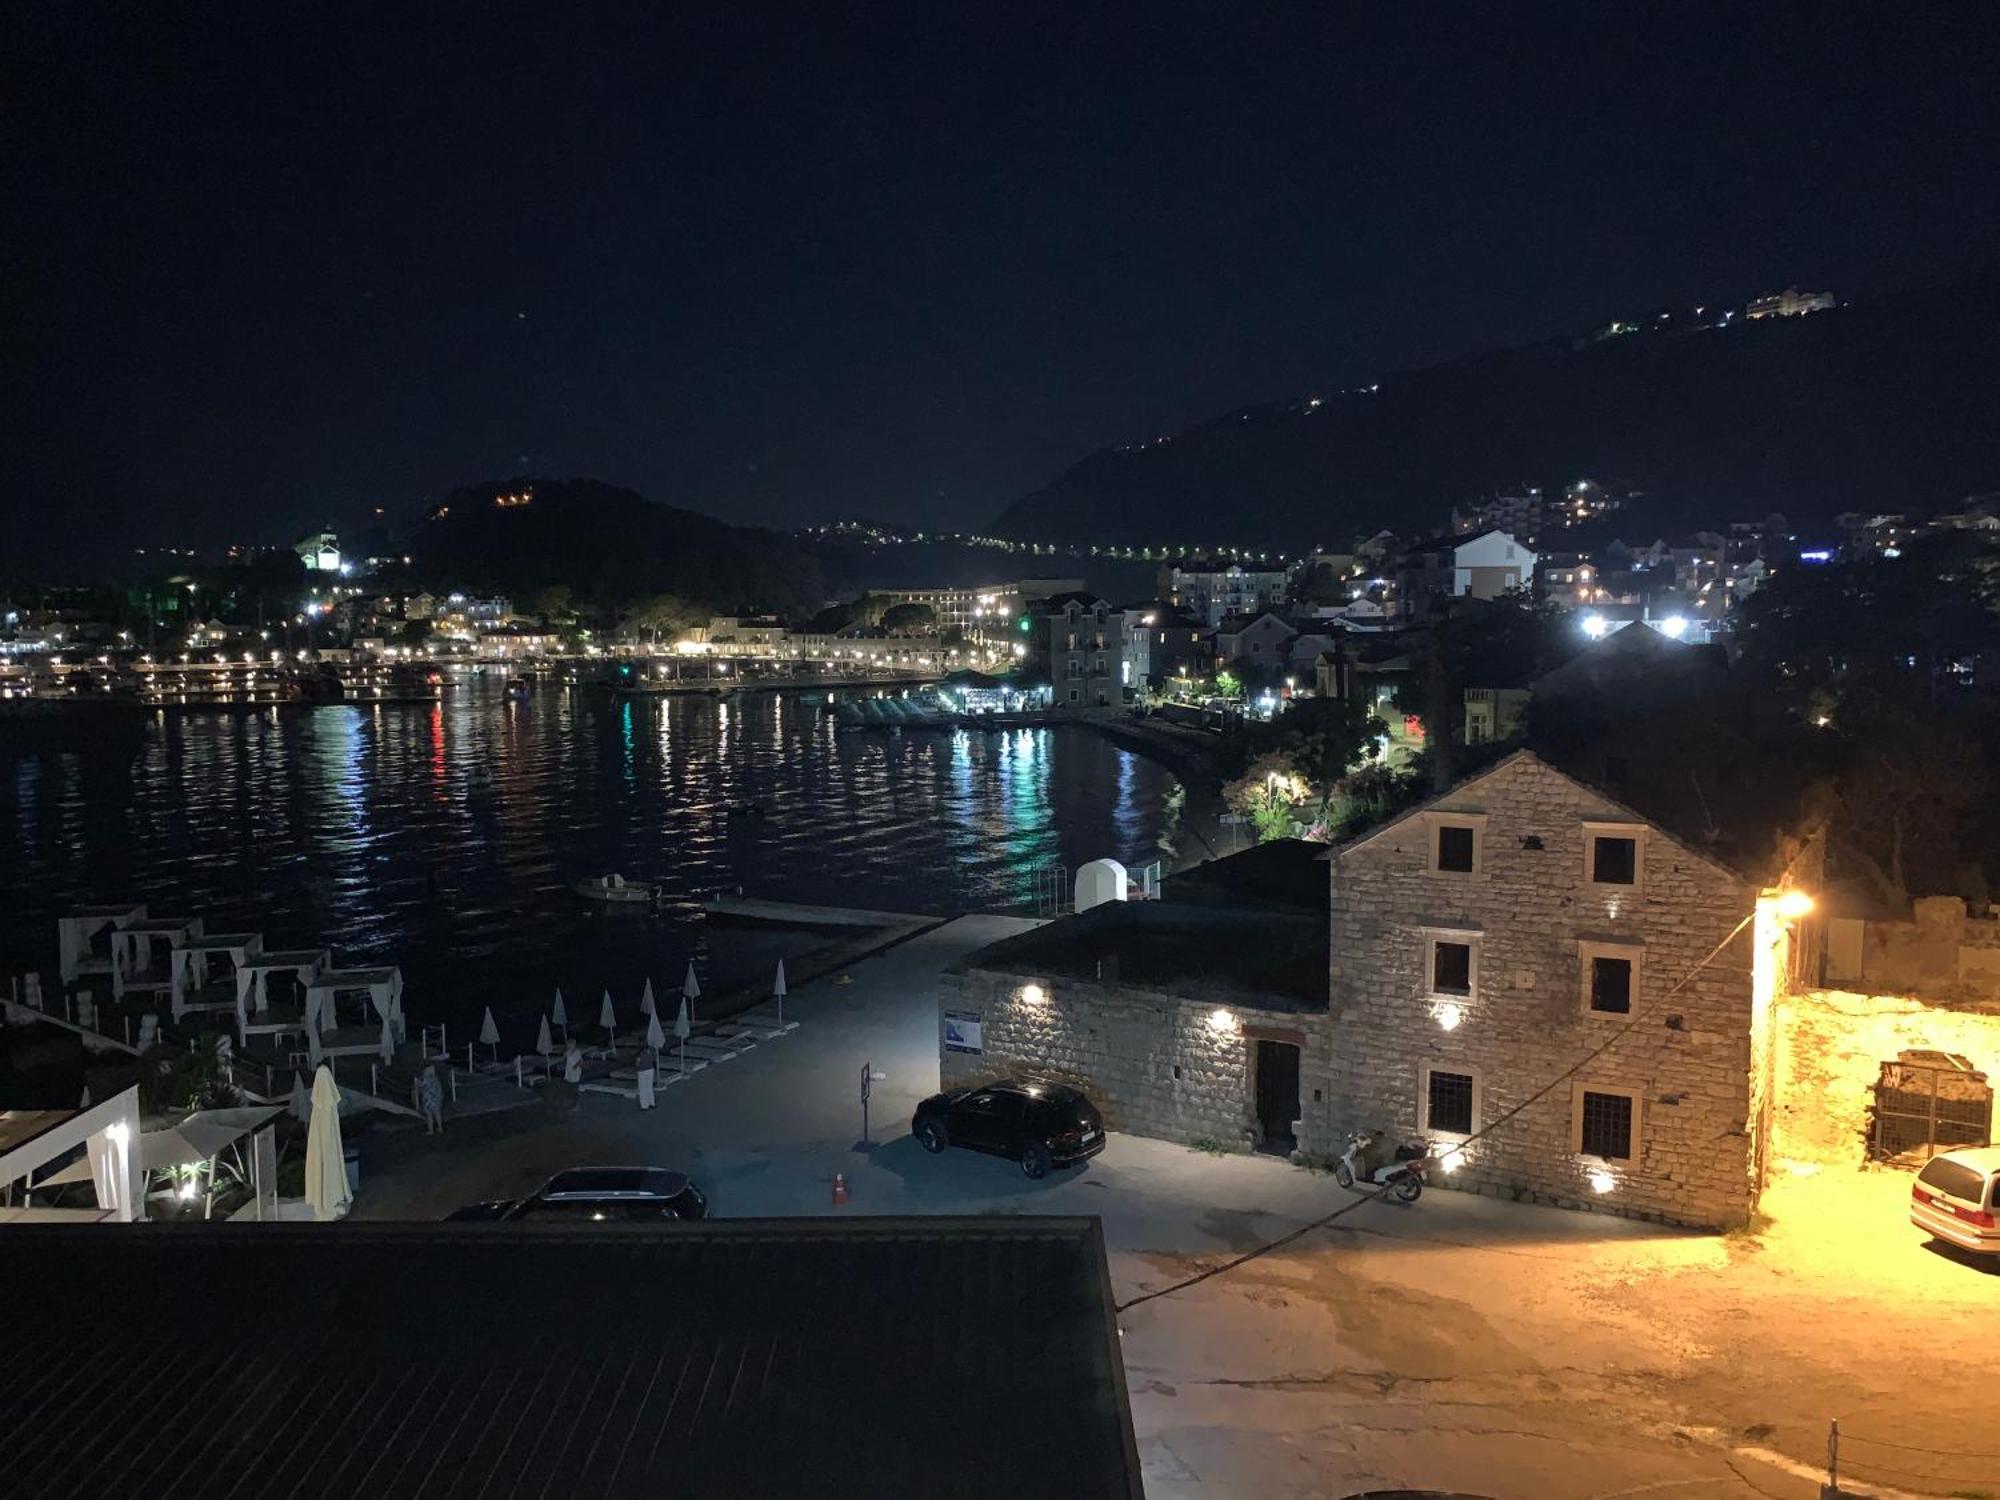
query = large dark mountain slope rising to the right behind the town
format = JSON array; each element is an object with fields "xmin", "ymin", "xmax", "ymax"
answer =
[{"xmin": 992, "ymin": 264, "xmax": 2000, "ymax": 548}]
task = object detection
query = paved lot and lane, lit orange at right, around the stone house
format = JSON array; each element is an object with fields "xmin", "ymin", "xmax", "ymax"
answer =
[{"xmin": 356, "ymin": 918, "xmax": 2000, "ymax": 1500}]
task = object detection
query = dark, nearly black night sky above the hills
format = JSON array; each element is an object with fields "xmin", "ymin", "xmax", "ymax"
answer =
[{"xmin": 0, "ymin": 0, "xmax": 2000, "ymax": 552}]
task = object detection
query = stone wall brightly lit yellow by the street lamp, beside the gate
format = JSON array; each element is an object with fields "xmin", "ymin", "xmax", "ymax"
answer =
[{"xmin": 1772, "ymin": 990, "xmax": 2000, "ymax": 1166}]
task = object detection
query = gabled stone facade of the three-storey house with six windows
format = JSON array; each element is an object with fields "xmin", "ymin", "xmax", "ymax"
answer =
[{"xmin": 1336, "ymin": 754, "xmax": 1756, "ymax": 1226}]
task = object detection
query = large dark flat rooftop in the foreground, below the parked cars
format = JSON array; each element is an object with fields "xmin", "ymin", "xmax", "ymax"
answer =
[{"xmin": 0, "ymin": 1218, "xmax": 1140, "ymax": 1500}]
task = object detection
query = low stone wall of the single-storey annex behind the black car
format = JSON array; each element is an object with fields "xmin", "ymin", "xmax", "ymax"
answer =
[{"xmin": 938, "ymin": 968, "xmax": 1328, "ymax": 1152}]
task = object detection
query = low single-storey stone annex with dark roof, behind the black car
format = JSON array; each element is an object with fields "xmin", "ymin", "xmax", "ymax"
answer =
[{"xmin": 938, "ymin": 840, "xmax": 1332, "ymax": 1156}]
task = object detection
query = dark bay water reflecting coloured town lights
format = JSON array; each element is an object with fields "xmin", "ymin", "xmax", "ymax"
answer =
[{"xmin": 0, "ymin": 676, "xmax": 1176, "ymax": 1030}]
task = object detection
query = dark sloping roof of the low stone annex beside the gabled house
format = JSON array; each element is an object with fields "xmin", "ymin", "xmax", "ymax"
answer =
[{"xmin": 956, "ymin": 840, "xmax": 1328, "ymax": 1010}]
